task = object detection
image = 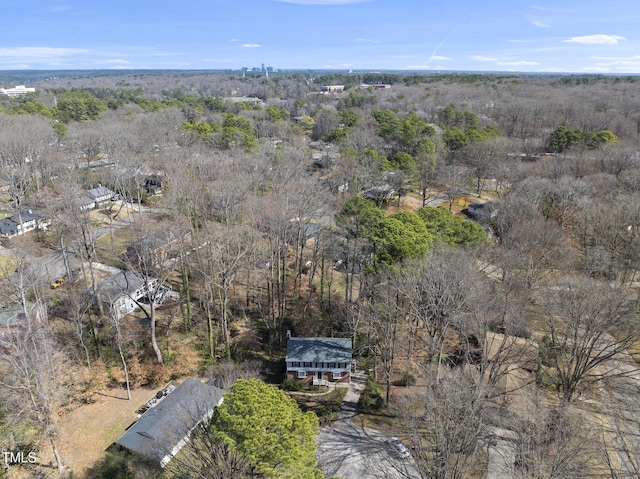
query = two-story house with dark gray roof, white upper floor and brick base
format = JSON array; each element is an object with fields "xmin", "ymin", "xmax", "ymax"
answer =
[{"xmin": 286, "ymin": 338, "xmax": 352, "ymax": 384}]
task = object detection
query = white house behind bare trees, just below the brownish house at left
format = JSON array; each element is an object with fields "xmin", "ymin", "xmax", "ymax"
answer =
[{"xmin": 94, "ymin": 271, "xmax": 159, "ymax": 318}]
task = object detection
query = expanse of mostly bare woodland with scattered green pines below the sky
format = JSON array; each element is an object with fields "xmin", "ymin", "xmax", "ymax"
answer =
[{"xmin": 0, "ymin": 72, "xmax": 640, "ymax": 479}]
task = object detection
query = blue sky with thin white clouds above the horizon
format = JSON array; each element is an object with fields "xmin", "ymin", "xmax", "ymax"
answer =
[{"xmin": 0, "ymin": 0, "xmax": 640, "ymax": 73}]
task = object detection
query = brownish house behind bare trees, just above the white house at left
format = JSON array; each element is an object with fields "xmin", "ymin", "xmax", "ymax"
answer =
[{"xmin": 127, "ymin": 225, "xmax": 192, "ymax": 268}]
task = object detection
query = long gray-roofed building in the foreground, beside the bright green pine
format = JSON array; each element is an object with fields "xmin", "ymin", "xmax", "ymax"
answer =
[{"xmin": 115, "ymin": 378, "xmax": 224, "ymax": 467}]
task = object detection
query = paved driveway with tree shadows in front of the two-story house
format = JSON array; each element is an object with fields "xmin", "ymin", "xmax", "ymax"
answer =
[{"xmin": 317, "ymin": 377, "xmax": 420, "ymax": 479}]
